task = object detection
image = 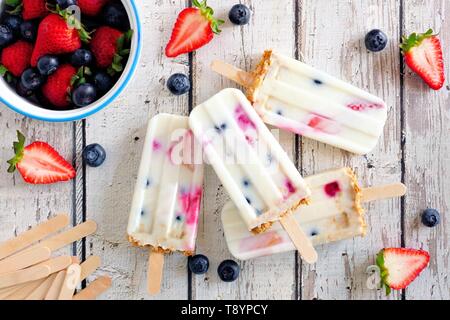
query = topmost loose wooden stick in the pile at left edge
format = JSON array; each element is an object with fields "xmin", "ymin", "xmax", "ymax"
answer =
[{"xmin": 0, "ymin": 214, "xmax": 69, "ymax": 260}]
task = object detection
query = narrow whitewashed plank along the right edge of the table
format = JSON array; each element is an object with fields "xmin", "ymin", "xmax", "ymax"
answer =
[{"xmin": 403, "ymin": 0, "xmax": 450, "ymax": 299}]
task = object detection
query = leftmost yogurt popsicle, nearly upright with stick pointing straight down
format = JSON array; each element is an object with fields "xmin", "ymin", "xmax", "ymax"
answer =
[{"xmin": 127, "ymin": 114, "xmax": 203, "ymax": 293}]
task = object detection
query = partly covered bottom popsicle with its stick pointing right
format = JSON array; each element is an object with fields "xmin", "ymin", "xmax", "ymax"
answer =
[{"xmin": 222, "ymin": 168, "xmax": 406, "ymax": 260}]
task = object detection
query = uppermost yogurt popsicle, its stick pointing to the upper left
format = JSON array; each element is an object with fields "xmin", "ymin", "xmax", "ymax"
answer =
[{"xmin": 212, "ymin": 51, "xmax": 387, "ymax": 154}]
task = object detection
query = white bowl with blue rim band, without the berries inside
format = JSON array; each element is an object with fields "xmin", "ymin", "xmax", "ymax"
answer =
[{"xmin": 0, "ymin": 0, "xmax": 142, "ymax": 122}]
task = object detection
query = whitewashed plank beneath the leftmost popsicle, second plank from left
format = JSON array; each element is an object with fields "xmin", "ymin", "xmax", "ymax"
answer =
[{"xmin": 86, "ymin": 0, "xmax": 189, "ymax": 299}]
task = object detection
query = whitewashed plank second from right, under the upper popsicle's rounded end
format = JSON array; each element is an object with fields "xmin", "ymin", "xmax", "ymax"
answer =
[{"xmin": 298, "ymin": 0, "xmax": 401, "ymax": 299}]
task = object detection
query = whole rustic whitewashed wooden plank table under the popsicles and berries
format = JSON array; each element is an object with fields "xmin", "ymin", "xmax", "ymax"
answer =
[{"xmin": 0, "ymin": 0, "xmax": 450, "ymax": 299}]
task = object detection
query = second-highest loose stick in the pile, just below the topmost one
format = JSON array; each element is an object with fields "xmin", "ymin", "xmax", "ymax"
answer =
[{"xmin": 13, "ymin": 220, "xmax": 97, "ymax": 258}]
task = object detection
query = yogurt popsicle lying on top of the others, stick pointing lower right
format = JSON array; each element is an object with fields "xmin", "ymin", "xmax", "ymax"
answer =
[{"xmin": 189, "ymin": 89, "xmax": 317, "ymax": 262}]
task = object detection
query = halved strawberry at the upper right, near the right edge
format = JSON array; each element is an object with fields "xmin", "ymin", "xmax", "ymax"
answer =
[{"xmin": 400, "ymin": 29, "xmax": 445, "ymax": 90}]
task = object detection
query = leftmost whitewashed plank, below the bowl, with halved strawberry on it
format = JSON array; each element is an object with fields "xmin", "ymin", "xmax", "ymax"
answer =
[{"xmin": 0, "ymin": 109, "xmax": 73, "ymax": 254}]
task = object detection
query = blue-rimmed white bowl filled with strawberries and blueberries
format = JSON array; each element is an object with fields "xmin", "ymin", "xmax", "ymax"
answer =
[{"xmin": 0, "ymin": 0, "xmax": 142, "ymax": 122}]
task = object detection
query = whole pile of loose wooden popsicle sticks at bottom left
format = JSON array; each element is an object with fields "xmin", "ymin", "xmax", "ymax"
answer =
[{"xmin": 0, "ymin": 215, "xmax": 111, "ymax": 300}]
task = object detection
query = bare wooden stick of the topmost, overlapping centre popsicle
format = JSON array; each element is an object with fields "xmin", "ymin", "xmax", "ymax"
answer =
[{"xmin": 280, "ymin": 214, "xmax": 318, "ymax": 264}]
